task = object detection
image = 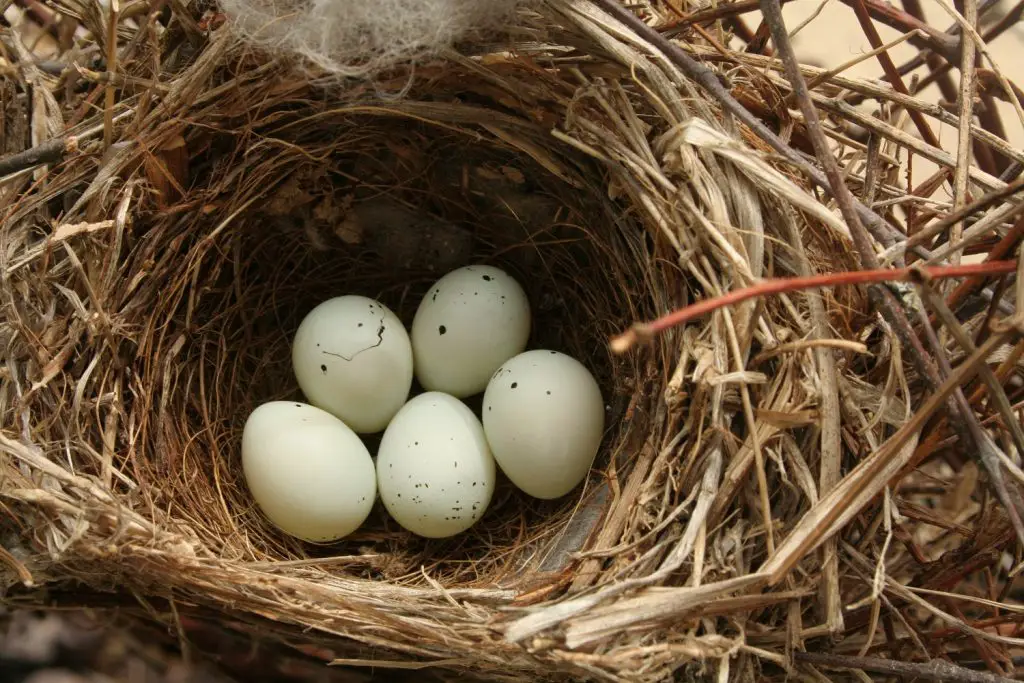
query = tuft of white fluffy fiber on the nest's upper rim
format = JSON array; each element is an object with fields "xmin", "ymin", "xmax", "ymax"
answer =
[{"xmin": 221, "ymin": 0, "xmax": 521, "ymax": 77}]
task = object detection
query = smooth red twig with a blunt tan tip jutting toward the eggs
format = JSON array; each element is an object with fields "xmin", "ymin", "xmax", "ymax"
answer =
[{"xmin": 610, "ymin": 261, "xmax": 1017, "ymax": 353}]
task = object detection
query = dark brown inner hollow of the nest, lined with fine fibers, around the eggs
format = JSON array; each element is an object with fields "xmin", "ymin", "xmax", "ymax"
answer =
[{"xmin": 158, "ymin": 102, "xmax": 646, "ymax": 573}]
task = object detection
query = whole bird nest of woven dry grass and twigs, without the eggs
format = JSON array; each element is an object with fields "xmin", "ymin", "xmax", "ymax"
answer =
[{"xmin": 6, "ymin": 0, "xmax": 1024, "ymax": 681}]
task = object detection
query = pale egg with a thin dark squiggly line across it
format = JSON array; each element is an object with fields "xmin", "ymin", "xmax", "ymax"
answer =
[{"xmin": 292, "ymin": 295, "xmax": 413, "ymax": 434}]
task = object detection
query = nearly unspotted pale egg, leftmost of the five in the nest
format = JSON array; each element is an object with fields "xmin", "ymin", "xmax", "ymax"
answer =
[{"xmin": 242, "ymin": 400, "xmax": 377, "ymax": 542}]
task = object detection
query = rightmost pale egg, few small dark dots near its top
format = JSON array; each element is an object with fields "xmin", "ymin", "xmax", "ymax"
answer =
[{"xmin": 483, "ymin": 350, "xmax": 604, "ymax": 499}]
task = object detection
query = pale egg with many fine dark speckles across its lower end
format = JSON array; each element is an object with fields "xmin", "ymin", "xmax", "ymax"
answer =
[{"xmin": 377, "ymin": 391, "xmax": 497, "ymax": 539}]
